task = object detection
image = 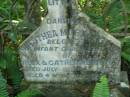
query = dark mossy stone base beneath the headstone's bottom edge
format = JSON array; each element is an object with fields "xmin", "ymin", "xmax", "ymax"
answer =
[{"xmin": 30, "ymin": 83, "xmax": 95, "ymax": 97}]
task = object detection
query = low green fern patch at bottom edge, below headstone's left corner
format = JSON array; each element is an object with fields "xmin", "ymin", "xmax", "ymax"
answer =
[{"xmin": 16, "ymin": 89, "xmax": 43, "ymax": 97}]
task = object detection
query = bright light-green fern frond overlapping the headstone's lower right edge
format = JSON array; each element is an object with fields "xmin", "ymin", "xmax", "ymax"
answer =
[{"xmin": 93, "ymin": 76, "xmax": 110, "ymax": 97}]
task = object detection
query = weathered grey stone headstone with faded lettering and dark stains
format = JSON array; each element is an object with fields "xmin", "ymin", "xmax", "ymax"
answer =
[{"xmin": 19, "ymin": 0, "xmax": 121, "ymax": 84}]
